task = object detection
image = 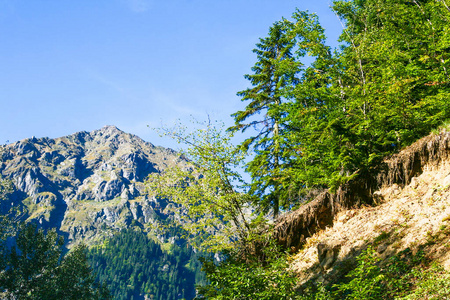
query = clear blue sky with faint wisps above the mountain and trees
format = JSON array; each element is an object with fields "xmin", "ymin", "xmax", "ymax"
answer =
[{"xmin": 0, "ymin": 0, "xmax": 341, "ymax": 147}]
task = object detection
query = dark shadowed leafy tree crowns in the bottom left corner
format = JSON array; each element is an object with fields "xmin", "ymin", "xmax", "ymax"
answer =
[{"xmin": 0, "ymin": 224, "xmax": 109, "ymax": 299}]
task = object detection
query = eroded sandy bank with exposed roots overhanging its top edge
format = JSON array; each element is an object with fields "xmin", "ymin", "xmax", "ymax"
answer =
[{"xmin": 284, "ymin": 127, "xmax": 450, "ymax": 285}]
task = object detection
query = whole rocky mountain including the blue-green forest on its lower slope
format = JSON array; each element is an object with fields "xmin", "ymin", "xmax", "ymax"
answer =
[{"xmin": 0, "ymin": 126, "xmax": 203, "ymax": 300}]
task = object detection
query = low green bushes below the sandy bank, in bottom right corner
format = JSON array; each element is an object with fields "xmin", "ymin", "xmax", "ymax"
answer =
[{"xmin": 300, "ymin": 247, "xmax": 450, "ymax": 300}]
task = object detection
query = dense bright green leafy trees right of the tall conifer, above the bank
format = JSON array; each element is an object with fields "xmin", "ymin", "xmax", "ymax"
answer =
[{"xmin": 283, "ymin": 0, "xmax": 450, "ymax": 193}]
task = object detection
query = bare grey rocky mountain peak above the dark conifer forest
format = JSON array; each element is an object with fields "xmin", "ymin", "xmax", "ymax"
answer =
[{"xmin": 0, "ymin": 126, "xmax": 186, "ymax": 243}]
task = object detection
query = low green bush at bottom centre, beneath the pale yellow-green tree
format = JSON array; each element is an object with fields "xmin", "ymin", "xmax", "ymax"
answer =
[{"xmin": 198, "ymin": 242, "xmax": 296, "ymax": 300}]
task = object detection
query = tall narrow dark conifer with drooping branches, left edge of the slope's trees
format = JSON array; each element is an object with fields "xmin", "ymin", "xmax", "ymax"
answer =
[{"xmin": 229, "ymin": 19, "xmax": 300, "ymax": 215}]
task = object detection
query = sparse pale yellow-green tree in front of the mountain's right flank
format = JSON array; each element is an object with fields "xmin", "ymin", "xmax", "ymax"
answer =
[{"xmin": 147, "ymin": 122, "xmax": 252, "ymax": 252}]
